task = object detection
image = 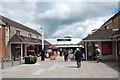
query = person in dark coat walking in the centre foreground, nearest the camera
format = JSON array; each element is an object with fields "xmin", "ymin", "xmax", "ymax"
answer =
[{"xmin": 75, "ymin": 48, "xmax": 83, "ymax": 68}]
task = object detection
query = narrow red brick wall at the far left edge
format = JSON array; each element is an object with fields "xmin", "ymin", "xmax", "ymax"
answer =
[{"xmin": 0, "ymin": 26, "xmax": 5, "ymax": 58}]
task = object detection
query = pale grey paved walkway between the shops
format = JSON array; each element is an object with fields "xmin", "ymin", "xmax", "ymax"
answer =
[{"xmin": 2, "ymin": 57, "xmax": 118, "ymax": 78}]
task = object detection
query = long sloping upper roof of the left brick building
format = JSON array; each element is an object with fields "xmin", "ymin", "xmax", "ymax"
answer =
[{"xmin": 0, "ymin": 15, "xmax": 41, "ymax": 36}]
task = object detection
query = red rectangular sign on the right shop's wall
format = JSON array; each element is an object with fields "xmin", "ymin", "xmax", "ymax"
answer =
[{"xmin": 102, "ymin": 42, "xmax": 112, "ymax": 55}]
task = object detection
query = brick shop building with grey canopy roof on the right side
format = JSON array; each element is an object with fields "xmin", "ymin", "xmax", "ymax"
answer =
[{"xmin": 82, "ymin": 12, "xmax": 120, "ymax": 60}]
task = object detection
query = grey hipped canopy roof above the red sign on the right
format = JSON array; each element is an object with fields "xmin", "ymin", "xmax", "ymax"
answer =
[{"xmin": 83, "ymin": 29, "xmax": 116, "ymax": 41}]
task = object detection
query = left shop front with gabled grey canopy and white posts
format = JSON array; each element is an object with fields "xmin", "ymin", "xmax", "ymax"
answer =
[{"xmin": 7, "ymin": 35, "xmax": 42, "ymax": 65}]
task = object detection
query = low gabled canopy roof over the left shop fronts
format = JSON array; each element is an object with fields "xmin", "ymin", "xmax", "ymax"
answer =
[{"xmin": 9, "ymin": 34, "xmax": 50, "ymax": 45}]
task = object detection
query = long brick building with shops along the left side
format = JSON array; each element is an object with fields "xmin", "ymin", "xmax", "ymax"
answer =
[{"xmin": 0, "ymin": 16, "xmax": 50, "ymax": 60}]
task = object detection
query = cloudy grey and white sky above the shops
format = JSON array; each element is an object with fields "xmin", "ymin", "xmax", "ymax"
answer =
[{"xmin": 0, "ymin": 0, "xmax": 118, "ymax": 38}]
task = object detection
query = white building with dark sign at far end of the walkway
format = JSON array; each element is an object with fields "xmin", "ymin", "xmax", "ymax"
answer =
[{"xmin": 46, "ymin": 38, "xmax": 82, "ymax": 48}]
